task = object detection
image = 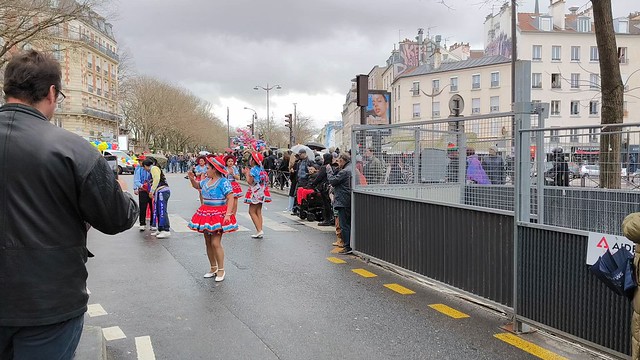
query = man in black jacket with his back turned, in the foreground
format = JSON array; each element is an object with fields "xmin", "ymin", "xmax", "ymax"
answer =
[{"xmin": 0, "ymin": 50, "xmax": 138, "ymax": 359}]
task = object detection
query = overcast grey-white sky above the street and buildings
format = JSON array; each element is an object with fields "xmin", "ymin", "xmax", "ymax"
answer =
[{"xmin": 113, "ymin": 0, "xmax": 640, "ymax": 127}]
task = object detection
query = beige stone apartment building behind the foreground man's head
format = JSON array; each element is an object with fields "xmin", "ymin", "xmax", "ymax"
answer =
[{"xmin": 50, "ymin": 12, "xmax": 120, "ymax": 142}]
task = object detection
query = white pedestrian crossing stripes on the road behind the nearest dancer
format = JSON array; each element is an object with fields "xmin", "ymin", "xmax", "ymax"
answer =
[{"xmin": 169, "ymin": 212, "xmax": 335, "ymax": 233}]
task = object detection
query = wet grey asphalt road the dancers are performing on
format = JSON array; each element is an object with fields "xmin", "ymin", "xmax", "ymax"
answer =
[{"xmin": 86, "ymin": 174, "xmax": 604, "ymax": 359}]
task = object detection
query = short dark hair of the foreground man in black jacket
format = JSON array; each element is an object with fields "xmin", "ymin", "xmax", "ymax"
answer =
[{"xmin": 3, "ymin": 50, "xmax": 62, "ymax": 104}]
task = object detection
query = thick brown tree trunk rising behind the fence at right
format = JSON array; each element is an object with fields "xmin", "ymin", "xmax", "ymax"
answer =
[{"xmin": 591, "ymin": 0, "xmax": 624, "ymax": 189}]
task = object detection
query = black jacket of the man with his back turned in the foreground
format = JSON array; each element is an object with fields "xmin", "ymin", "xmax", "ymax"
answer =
[{"xmin": 0, "ymin": 104, "xmax": 138, "ymax": 326}]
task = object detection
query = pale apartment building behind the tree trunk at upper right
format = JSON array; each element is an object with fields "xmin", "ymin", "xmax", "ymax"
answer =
[{"xmin": 485, "ymin": 0, "xmax": 640, "ymax": 146}]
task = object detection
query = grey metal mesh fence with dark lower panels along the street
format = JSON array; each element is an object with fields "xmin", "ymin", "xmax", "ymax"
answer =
[{"xmin": 352, "ymin": 113, "xmax": 640, "ymax": 356}]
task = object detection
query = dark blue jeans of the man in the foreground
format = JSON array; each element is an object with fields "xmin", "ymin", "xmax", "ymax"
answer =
[{"xmin": 0, "ymin": 314, "xmax": 84, "ymax": 360}]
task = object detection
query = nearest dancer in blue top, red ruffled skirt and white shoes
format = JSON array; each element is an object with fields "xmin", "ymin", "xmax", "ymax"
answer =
[{"xmin": 189, "ymin": 156, "xmax": 238, "ymax": 281}]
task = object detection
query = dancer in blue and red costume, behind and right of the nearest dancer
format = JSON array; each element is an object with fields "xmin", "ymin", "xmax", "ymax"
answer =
[{"xmin": 244, "ymin": 151, "xmax": 271, "ymax": 239}]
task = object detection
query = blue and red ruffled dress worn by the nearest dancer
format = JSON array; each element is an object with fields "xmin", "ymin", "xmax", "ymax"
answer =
[{"xmin": 189, "ymin": 178, "xmax": 238, "ymax": 234}]
